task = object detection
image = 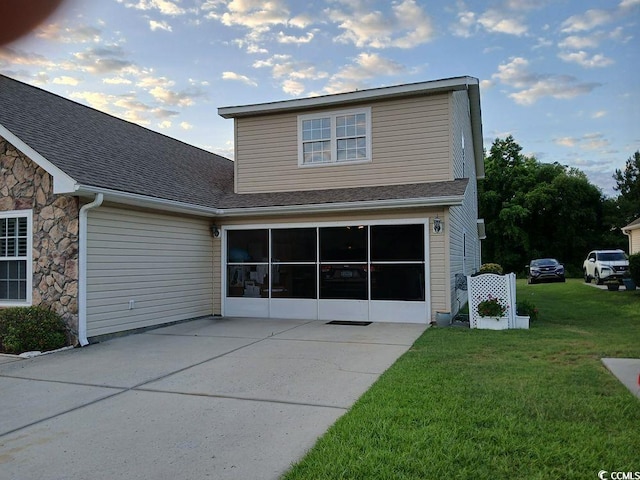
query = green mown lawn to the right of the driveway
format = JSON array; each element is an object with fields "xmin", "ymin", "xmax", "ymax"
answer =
[{"xmin": 283, "ymin": 280, "xmax": 640, "ymax": 480}]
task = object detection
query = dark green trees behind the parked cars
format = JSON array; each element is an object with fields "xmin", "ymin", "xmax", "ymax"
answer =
[{"xmin": 478, "ymin": 135, "xmax": 640, "ymax": 276}]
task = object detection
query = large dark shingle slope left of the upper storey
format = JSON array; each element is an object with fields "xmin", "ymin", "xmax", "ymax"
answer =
[{"xmin": 0, "ymin": 75, "xmax": 233, "ymax": 206}]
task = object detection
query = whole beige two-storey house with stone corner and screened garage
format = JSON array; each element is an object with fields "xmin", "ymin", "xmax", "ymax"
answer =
[{"xmin": 0, "ymin": 76, "xmax": 484, "ymax": 345}]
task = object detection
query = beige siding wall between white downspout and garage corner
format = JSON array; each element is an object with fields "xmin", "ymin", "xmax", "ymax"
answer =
[{"xmin": 87, "ymin": 207, "xmax": 214, "ymax": 337}]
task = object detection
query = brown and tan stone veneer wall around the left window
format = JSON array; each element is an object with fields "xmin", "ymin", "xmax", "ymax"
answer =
[{"xmin": 0, "ymin": 137, "xmax": 79, "ymax": 338}]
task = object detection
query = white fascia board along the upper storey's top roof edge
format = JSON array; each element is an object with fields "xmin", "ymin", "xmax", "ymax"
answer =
[{"xmin": 218, "ymin": 76, "xmax": 478, "ymax": 118}]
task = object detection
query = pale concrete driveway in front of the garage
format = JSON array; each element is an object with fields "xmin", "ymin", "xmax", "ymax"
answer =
[{"xmin": 0, "ymin": 317, "xmax": 425, "ymax": 480}]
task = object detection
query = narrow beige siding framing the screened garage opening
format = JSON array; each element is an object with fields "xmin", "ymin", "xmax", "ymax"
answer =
[{"xmin": 214, "ymin": 208, "xmax": 450, "ymax": 319}]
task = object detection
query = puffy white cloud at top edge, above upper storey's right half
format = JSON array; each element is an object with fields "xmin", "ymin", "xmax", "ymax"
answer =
[{"xmin": 329, "ymin": 0, "xmax": 435, "ymax": 48}]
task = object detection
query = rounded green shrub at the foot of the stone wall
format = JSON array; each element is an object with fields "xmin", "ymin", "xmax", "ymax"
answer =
[{"xmin": 0, "ymin": 307, "xmax": 69, "ymax": 353}]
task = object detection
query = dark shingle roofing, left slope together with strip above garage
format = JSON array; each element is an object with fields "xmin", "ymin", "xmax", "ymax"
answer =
[{"xmin": 0, "ymin": 75, "xmax": 468, "ymax": 208}]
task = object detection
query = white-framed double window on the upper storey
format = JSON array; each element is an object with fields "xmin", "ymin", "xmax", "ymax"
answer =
[{"xmin": 298, "ymin": 108, "xmax": 371, "ymax": 166}]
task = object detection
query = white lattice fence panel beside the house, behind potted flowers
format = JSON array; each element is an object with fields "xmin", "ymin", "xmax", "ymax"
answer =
[{"xmin": 467, "ymin": 273, "xmax": 516, "ymax": 328}]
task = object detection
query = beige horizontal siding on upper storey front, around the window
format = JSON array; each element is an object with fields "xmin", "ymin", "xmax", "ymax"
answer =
[{"xmin": 235, "ymin": 94, "xmax": 451, "ymax": 193}]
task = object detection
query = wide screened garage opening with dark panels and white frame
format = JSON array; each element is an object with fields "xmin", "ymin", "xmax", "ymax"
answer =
[{"xmin": 225, "ymin": 221, "xmax": 427, "ymax": 321}]
